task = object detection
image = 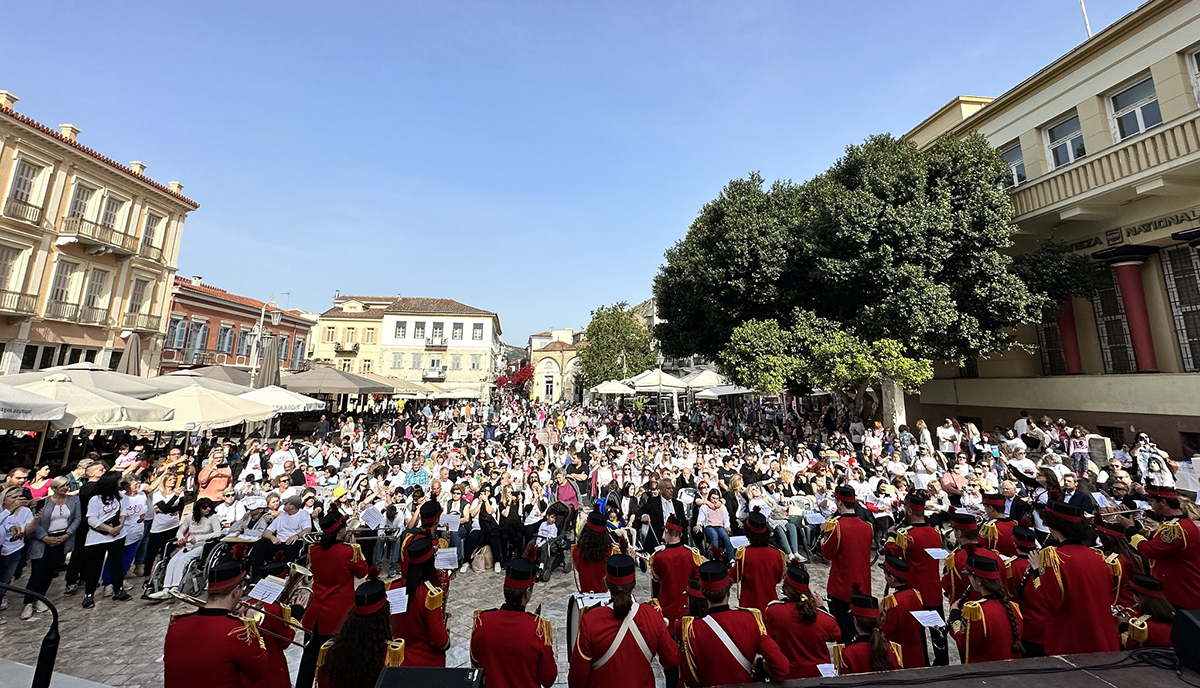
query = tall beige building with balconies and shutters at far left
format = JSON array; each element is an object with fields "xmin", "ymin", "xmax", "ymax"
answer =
[{"xmin": 0, "ymin": 91, "xmax": 199, "ymax": 373}]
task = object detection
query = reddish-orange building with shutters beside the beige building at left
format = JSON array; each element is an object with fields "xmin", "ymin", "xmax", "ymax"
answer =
[{"xmin": 160, "ymin": 275, "xmax": 314, "ymax": 373}]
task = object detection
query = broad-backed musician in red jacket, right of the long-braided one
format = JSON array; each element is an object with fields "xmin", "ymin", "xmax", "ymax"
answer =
[{"xmin": 1027, "ymin": 502, "xmax": 1121, "ymax": 654}]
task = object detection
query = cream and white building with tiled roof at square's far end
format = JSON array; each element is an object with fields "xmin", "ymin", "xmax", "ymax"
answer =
[{"xmin": 313, "ymin": 295, "xmax": 504, "ymax": 399}]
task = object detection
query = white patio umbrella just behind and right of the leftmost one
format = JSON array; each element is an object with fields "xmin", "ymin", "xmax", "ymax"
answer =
[{"xmin": 18, "ymin": 372, "xmax": 174, "ymax": 430}]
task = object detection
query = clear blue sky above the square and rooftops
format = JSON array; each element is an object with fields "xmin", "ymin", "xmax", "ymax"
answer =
[{"xmin": 0, "ymin": 0, "xmax": 1139, "ymax": 346}]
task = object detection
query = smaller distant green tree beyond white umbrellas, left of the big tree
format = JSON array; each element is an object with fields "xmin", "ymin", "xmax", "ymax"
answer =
[{"xmin": 575, "ymin": 301, "xmax": 656, "ymax": 388}]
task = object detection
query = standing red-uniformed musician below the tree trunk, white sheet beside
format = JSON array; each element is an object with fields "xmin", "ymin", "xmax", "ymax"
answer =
[{"xmin": 882, "ymin": 490, "xmax": 950, "ymax": 666}]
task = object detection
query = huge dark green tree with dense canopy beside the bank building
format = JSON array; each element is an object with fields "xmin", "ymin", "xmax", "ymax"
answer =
[{"xmin": 654, "ymin": 134, "xmax": 1043, "ymax": 363}]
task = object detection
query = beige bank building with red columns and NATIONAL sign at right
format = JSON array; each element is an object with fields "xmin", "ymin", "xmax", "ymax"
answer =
[{"xmin": 908, "ymin": 0, "xmax": 1200, "ymax": 456}]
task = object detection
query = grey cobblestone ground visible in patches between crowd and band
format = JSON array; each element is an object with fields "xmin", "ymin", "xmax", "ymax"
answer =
[{"xmin": 0, "ymin": 545, "xmax": 883, "ymax": 688}]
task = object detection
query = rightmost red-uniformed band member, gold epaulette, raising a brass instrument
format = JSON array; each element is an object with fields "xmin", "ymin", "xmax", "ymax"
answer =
[{"xmin": 1126, "ymin": 486, "xmax": 1200, "ymax": 609}]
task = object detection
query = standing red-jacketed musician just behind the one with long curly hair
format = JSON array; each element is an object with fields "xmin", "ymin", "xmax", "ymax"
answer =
[{"xmin": 296, "ymin": 511, "xmax": 367, "ymax": 688}]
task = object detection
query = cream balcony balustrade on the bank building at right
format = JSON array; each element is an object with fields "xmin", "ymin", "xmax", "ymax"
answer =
[{"xmin": 1013, "ymin": 110, "xmax": 1200, "ymax": 217}]
